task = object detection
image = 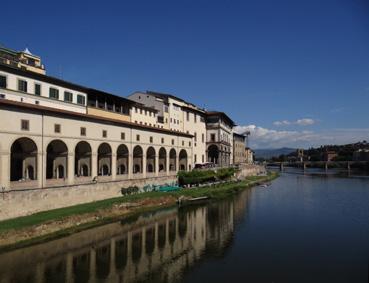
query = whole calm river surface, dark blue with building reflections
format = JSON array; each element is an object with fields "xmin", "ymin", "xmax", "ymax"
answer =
[{"xmin": 0, "ymin": 171, "xmax": 369, "ymax": 283}]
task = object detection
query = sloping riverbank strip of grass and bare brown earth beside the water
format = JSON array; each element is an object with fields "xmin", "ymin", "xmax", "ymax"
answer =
[{"xmin": 0, "ymin": 173, "xmax": 278, "ymax": 250}]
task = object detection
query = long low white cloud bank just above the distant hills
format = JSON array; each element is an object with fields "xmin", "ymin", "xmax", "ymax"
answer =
[{"xmin": 235, "ymin": 125, "xmax": 369, "ymax": 148}]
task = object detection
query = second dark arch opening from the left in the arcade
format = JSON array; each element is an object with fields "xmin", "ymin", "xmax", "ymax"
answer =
[{"xmin": 46, "ymin": 140, "xmax": 68, "ymax": 179}]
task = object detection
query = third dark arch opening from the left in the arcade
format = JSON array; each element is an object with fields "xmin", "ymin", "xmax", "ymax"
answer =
[{"xmin": 74, "ymin": 141, "xmax": 92, "ymax": 177}]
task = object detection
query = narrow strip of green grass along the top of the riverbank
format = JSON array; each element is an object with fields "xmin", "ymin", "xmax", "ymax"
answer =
[{"xmin": 0, "ymin": 173, "xmax": 277, "ymax": 233}]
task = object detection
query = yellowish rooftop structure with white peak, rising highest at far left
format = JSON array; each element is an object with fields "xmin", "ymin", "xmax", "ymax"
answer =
[{"xmin": 0, "ymin": 46, "xmax": 46, "ymax": 75}]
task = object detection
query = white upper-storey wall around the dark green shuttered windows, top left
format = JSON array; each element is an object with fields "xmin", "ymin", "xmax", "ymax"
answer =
[{"xmin": 0, "ymin": 71, "xmax": 87, "ymax": 113}]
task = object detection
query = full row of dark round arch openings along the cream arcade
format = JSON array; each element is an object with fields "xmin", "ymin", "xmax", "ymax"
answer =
[{"xmin": 10, "ymin": 137, "xmax": 188, "ymax": 181}]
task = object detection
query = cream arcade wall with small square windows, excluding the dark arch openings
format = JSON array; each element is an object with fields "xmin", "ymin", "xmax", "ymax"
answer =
[{"xmin": 0, "ymin": 105, "xmax": 193, "ymax": 192}]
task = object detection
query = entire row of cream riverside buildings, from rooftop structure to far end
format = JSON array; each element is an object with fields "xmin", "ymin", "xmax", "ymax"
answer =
[{"xmin": 0, "ymin": 45, "xmax": 240, "ymax": 194}]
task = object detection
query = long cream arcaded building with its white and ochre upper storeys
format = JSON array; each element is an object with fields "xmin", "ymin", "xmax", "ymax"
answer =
[{"xmin": 0, "ymin": 55, "xmax": 193, "ymax": 190}]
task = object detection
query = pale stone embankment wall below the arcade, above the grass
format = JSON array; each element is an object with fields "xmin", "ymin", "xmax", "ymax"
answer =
[{"xmin": 0, "ymin": 176, "xmax": 177, "ymax": 221}]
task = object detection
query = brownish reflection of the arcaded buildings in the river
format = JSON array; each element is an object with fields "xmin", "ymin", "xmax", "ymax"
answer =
[{"xmin": 0, "ymin": 190, "xmax": 251, "ymax": 283}]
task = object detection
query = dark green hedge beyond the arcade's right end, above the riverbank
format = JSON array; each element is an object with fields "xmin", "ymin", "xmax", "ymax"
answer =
[{"xmin": 178, "ymin": 168, "xmax": 236, "ymax": 186}]
